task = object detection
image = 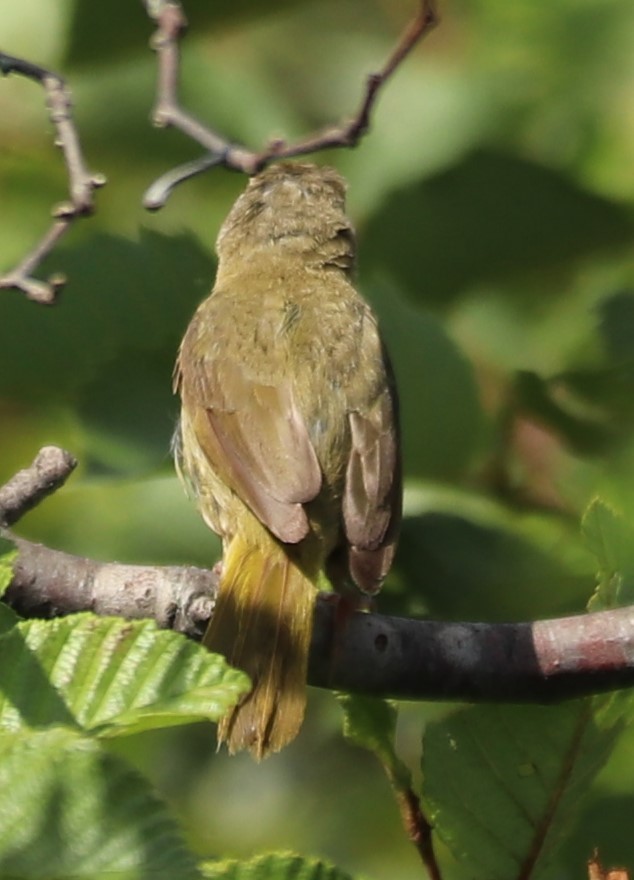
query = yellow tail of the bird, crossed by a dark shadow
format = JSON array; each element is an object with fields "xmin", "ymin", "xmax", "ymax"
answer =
[{"xmin": 204, "ymin": 529, "xmax": 316, "ymax": 760}]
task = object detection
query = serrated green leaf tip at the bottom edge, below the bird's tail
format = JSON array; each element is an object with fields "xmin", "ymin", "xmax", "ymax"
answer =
[{"xmin": 200, "ymin": 853, "xmax": 360, "ymax": 880}]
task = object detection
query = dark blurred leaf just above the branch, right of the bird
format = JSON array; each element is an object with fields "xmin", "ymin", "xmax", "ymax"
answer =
[{"xmin": 396, "ymin": 506, "xmax": 594, "ymax": 621}]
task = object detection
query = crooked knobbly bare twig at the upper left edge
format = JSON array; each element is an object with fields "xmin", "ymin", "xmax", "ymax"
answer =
[{"xmin": 0, "ymin": 52, "xmax": 106, "ymax": 304}]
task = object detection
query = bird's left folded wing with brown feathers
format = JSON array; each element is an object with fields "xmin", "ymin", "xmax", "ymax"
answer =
[{"xmin": 182, "ymin": 359, "xmax": 321, "ymax": 543}]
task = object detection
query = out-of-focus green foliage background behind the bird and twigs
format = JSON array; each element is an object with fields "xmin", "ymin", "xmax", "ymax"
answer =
[{"xmin": 0, "ymin": 0, "xmax": 634, "ymax": 880}]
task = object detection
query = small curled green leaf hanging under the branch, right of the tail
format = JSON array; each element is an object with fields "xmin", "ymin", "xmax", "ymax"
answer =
[{"xmin": 338, "ymin": 694, "xmax": 412, "ymax": 790}]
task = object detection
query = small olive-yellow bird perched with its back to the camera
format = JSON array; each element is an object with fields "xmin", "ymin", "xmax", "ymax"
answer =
[{"xmin": 174, "ymin": 163, "xmax": 401, "ymax": 759}]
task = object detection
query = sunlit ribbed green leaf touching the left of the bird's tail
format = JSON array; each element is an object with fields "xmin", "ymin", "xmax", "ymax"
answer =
[{"xmin": 0, "ymin": 614, "xmax": 249, "ymax": 737}]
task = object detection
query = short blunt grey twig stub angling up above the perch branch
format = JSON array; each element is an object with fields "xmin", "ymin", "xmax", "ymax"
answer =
[{"xmin": 0, "ymin": 446, "xmax": 77, "ymax": 527}]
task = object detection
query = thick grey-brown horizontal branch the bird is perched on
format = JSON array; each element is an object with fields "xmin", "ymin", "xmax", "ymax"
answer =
[{"xmin": 6, "ymin": 539, "xmax": 634, "ymax": 703}]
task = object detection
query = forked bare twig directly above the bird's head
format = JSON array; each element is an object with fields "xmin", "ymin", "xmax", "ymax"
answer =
[{"xmin": 143, "ymin": 0, "xmax": 438, "ymax": 210}]
